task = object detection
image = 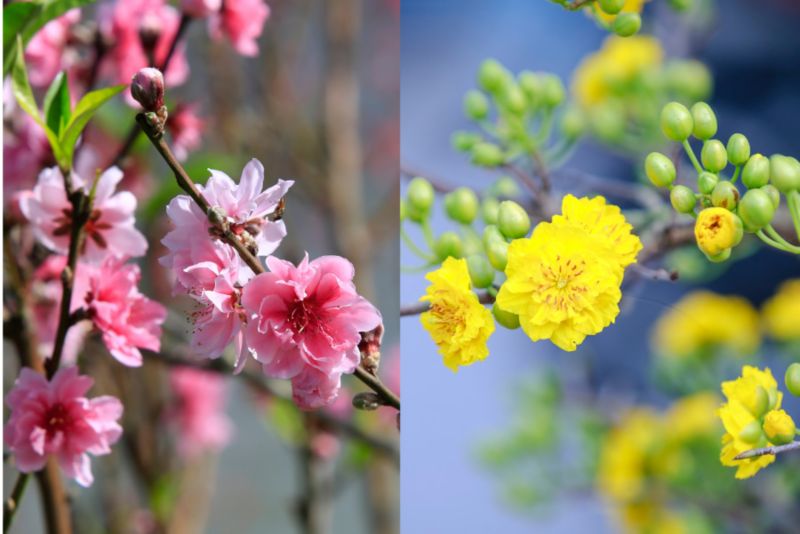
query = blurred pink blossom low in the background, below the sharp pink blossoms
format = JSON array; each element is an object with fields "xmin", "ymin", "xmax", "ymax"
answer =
[{"xmin": 168, "ymin": 367, "xmax": 233, "ymax": 456}]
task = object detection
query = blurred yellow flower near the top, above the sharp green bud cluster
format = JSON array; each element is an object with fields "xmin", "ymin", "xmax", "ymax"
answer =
[{"xmin": 572, "ymin": 36, "xmax": 664, "ymax": 108}]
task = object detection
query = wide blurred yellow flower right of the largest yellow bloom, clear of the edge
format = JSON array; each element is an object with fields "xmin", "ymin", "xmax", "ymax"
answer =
[{"xmin": 652, "ymin": 291, "xmax": 761, "ymax": 358}]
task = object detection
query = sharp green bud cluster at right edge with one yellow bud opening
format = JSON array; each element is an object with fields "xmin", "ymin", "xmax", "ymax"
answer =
[{"xmin": 645, "ymin": 102, "xmax": 800, "ymax": 262}]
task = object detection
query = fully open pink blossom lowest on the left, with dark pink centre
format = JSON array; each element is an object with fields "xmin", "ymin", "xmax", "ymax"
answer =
[{"xmin": 4, "ymin": 367, "xmax": 122, "ymax": 487}]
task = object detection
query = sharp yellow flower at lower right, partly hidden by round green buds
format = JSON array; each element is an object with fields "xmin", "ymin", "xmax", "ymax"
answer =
[{"xmin": 718, "ymin": 365, "xmax": 783, "ymax": 478}]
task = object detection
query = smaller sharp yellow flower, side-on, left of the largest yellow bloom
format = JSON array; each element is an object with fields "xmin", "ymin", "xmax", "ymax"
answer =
[{"xmin": 420, "ymin": 258, "xmax": 494, "ymax": 371}]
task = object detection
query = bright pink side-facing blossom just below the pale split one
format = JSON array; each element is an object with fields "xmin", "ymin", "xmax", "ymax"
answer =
[{"xmin": 82, "ymin": 257, "xmax": 167, "ymax": 367}]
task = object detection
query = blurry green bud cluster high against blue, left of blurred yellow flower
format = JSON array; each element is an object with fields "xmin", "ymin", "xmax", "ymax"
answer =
[{"xmin": 452, "ymin": 59, "xmax": 584, "ymax": 175}]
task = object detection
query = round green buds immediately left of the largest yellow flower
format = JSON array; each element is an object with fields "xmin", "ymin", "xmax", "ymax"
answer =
[{"xmin": 400, "ymin": 177, "xmax": 531, "ymax": 329}]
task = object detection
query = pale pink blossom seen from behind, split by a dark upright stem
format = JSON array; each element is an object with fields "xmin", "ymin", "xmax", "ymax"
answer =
[{"xmin": 20, "ymin": 167, "xmax": 147, "ymax": 262}]
